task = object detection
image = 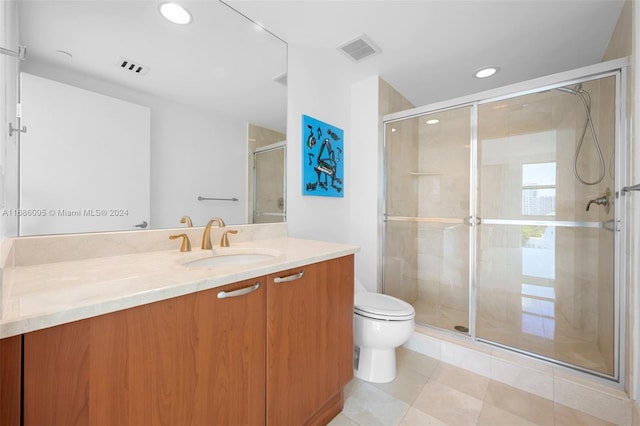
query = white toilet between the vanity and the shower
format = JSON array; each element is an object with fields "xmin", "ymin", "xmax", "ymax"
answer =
[{"xmin": 353, "ymin": 280, "xmax": 416, "ymax": 383}]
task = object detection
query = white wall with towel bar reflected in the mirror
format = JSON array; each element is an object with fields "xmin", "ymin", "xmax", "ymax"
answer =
[{"xmin": 23, "ymin": 61, "xmax": 247, "ymax": 228}]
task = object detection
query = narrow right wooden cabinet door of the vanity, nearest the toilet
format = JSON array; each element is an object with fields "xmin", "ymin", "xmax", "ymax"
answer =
[{"xmin": 267, "ymin": 256, "xmax": 353, "ymax": 425}]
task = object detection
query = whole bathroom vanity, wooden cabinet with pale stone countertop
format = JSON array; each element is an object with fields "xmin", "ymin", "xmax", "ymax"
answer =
[{"xmin": 0, "ymin": 225, "xmax": 357, "ymax": 426}]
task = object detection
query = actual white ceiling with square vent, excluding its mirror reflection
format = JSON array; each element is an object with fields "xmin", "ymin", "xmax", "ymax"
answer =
[{"xmin": 226, "ymin": 0, "xmax": 624, "ymax": 106}]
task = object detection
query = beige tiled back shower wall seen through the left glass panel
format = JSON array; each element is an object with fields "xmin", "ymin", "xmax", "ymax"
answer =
[{"xmin": 415, "ymin": 107, "xmax": 471, "ymax": 316}]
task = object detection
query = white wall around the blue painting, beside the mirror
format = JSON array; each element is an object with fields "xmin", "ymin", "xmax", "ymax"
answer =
[{"xmin": 287, "ymin": 45, "xmax": 380, "ymax": 291}]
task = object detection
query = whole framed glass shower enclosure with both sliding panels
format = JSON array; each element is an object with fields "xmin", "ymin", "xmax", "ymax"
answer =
[{"xmin": 382, "ymin": 59, "xmax": 626, "ymax": 380}]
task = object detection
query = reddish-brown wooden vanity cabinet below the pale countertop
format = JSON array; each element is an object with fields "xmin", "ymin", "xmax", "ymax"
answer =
[{"xmin": 12, "ymin": 255, "xmax": 353, "ymax": 426}]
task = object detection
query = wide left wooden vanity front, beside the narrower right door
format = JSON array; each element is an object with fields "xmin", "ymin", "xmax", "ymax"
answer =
[{"xmin": 24, "ymin": 278, "xmax": 266, "ymax": 426}]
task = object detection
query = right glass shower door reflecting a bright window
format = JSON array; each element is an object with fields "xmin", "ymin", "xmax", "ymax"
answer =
[{"xmin": 475, "ymin": 77, "xmax": 616, "ymax": 376}]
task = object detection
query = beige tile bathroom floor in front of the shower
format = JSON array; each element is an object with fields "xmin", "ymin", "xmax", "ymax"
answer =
[{"xmin": 329, "ymin": 348, "xmax": 611, "ymax": 426}]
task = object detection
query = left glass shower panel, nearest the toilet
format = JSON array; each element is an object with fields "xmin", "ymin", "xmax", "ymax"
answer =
[{"xmin": 383, "ymin": 106, "xmax": 471, "ymax": 333}]
